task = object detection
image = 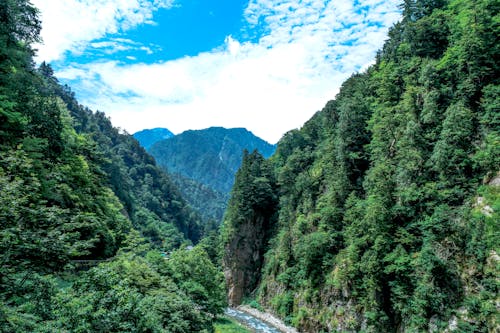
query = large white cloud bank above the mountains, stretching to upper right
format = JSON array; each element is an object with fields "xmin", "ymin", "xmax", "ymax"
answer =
[{"xmin": 33, "ymin": 0, "xmax": 400, "ymax": 142}]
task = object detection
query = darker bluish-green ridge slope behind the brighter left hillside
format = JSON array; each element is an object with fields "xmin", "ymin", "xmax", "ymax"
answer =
[{"xmin": 46, "ymin": 70, "xmax": 201, "ymax": 249}]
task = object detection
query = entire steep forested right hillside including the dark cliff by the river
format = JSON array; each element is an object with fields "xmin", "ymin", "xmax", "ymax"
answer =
[{"xmin": 224, "ymin": 0, "xmax": 500, "ymax": 332}]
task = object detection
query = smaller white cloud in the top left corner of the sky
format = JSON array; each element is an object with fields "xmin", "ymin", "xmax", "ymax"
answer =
[{"xmin": 32, "ymin": 0, "xmax": 173, "ymax": 61}]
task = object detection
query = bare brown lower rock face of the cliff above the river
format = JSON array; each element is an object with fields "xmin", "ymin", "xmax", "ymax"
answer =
[{"xmin": 224, "ymin": 216, "xmax": 267, "ymax": 306}]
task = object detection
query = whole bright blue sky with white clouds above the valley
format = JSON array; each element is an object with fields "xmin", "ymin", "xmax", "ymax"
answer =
[{"xmin": 32, "ymin": 0, "xmax": 400, "ymax": 143}]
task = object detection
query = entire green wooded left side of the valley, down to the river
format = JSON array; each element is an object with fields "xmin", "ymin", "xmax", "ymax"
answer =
[{"xmin": 0, "ymin": 0, "xmax": 225, "ymax": 333}]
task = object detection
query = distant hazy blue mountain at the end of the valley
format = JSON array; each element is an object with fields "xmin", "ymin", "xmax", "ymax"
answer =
[{"xmin": 149, "ymin": 127, "xmax": 276, "ymax": 223}]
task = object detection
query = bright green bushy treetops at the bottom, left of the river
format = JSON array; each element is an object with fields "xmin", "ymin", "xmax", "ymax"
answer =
[{"xmin": 48, "ymin": 240, "xmax": 224, "ymax": 333}]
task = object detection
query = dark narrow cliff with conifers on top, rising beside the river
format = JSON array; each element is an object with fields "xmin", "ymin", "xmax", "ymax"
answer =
[{"xmin": 223, "ymin": 151, "xmax": 278, "ymax": 306}]
